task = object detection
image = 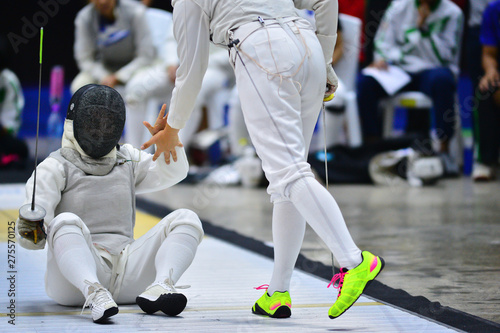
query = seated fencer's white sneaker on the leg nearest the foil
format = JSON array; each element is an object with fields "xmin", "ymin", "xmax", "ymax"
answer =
[{"xmin": 82, "ymin": 280, "xmax": 118, "ymax": 323}]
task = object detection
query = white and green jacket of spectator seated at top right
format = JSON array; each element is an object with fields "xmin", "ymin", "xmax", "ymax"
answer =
[{"xmin": 374, "ymin": 0, "xmax": 463, "ymax": 75}]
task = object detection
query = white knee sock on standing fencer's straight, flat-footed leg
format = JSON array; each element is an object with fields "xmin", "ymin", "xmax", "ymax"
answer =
[{"xmin": 267, "ymin": 201, "xmax": 306, "ymax": 295}]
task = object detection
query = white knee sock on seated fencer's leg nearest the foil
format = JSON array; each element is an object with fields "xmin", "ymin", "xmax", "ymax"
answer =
[{"xmin": 53, "ymin": 226, "xmax": 100, "ymax": 297}]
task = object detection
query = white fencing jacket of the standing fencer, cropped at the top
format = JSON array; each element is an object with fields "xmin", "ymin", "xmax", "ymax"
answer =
[{"xmin": 168, "ymin": 0, "xmax": 338, "ymax": 129}]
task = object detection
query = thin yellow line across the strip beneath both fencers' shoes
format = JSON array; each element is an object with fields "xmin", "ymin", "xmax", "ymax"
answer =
[{"xmin": 0, "ymin": 302, "xmax": 385, "ymax": 317}]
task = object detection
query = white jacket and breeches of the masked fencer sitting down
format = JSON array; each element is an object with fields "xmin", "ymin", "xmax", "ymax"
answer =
[{"xmin": 19, "ymin": 142, "xmax": 203, "ymax": 305}]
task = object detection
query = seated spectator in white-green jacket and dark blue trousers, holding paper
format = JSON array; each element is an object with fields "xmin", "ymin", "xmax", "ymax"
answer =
[{"xmin": 357, "ymin": 0, "xmax": 463, "ymax": 171}]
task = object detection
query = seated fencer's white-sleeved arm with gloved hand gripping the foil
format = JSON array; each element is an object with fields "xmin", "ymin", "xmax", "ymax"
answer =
[{"xmin": 15, "ymin": 157, "xmax": 66, "ymax": 250}]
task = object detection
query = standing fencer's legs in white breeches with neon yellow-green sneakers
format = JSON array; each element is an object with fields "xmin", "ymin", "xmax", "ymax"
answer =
[{"xmin": 233, "ymin": 22, "xmax": 383, "ymax": 318}]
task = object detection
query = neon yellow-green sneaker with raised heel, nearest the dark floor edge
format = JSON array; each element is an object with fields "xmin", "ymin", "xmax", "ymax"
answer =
[{"xmin": 328, "ymin": 251, "xmax": 385, "ymax": 319}]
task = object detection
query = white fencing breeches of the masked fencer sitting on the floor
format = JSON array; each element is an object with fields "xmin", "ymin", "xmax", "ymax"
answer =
[{"xmin": 45, "ymin": 209, "xmax": 203, "ymax": 306}]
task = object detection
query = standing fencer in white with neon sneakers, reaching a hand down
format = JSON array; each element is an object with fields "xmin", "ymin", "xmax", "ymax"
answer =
[{"xmin": 142, "ymin": 0, "xmax": 383, "ymax": 318}]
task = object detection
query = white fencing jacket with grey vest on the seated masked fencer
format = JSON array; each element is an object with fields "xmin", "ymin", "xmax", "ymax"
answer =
[{"xmin": 18, "ymin": 144, "xmax": 189, "ymax": 254}]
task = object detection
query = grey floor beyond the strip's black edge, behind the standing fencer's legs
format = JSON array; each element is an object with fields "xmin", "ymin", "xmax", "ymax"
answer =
[{"xmin": 143, "ymin": 178, "xmax": 500, "ymax": 323}]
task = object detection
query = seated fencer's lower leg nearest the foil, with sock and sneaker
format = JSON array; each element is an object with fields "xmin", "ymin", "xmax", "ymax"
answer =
[{"xmin": 48, "ymin": 214, "xmax": 118, "ymax": 322}]
